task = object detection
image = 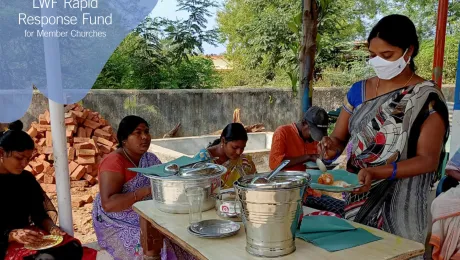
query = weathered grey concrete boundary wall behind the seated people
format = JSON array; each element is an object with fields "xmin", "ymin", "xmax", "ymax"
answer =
[{"xmin": 22, "ymin": 86, "xmax": 454, "ymax": 138}]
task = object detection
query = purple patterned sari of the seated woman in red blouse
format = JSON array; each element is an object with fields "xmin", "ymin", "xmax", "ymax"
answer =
[{"xmin": 93, "ymin": 153, "xmax": 161, "ymax": 260}]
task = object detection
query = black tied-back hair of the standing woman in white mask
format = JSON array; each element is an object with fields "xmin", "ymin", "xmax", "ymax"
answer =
[{"xmin": 367, "ymin": 14, "xmax": 420, "ymax": 71}]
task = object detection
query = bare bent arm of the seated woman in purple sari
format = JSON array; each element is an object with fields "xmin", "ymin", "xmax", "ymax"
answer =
[{"xmin": 99, "ymin": 171, "xmax": 150, "ymax": 212}]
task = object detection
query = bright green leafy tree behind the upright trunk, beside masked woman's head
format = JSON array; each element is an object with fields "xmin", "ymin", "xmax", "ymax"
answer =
[{"xmin": 218, "ymin": 0, "xmax": 382, "ymax": 86}]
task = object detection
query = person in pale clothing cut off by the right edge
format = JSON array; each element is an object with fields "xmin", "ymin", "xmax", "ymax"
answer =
[{"xmin": 430, "ymin": 150, "xmax": 460, "ymax": 260}]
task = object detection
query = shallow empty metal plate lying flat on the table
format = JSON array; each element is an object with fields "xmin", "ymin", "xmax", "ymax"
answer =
[{"xmin": 188, "ymin": 219, "xmax": 240, "ymax": 238}]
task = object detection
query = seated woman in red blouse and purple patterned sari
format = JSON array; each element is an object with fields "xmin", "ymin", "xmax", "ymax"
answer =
[{"xmin": 93, "ymin": 116, "xmax": 161, "ymax": 260}]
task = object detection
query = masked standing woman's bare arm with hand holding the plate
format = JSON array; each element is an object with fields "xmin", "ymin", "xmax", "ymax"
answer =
[{"xmin": 357, "ymin": 113, "xmax": 446, "ymax": 193}]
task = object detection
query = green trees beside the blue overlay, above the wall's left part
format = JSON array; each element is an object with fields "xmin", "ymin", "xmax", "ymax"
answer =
[{"xmin": 94, "ymin": 0, "xmax": 220, "ymax": 89}]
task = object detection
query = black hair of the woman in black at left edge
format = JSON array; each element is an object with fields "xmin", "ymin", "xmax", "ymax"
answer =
[{"xmin": 0, "ymin": 130, "xmax": 35, "ymax": 153}]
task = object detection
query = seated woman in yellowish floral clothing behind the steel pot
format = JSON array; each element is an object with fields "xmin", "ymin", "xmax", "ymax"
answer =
[{"xmin": 162, "ymin": 123, "xmax": 257, "ymax": 260}]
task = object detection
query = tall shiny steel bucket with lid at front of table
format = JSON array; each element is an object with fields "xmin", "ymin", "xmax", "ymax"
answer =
[{"xmin": 234, "ymin": 171, "xmax": 311, "ymax": 257}]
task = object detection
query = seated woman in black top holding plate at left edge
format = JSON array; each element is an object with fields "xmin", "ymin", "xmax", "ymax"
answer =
[{"xmin": 0, "ymin": 126, "xmax": 85, "ymax": 260}]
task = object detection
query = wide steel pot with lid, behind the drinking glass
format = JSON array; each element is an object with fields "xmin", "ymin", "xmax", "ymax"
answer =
[{"xmin": 146, "ymin": 163, "xmax": 227, "ymax": 214}]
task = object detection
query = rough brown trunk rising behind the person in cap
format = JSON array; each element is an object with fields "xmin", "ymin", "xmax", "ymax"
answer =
[{"xmin": 299, "ymin": 0, "xmax": 318, "ymax": 118}]
